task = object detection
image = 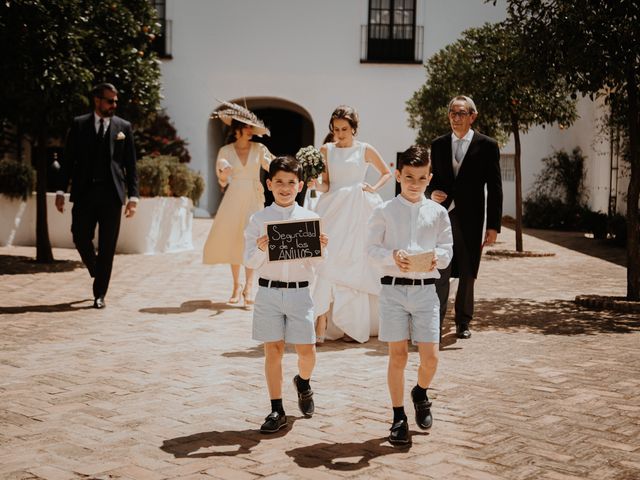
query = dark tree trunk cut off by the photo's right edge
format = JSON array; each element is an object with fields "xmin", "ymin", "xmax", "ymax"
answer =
[{"xmin": 627, "ymin": 67, "xmax": 640, "ymax": 301}]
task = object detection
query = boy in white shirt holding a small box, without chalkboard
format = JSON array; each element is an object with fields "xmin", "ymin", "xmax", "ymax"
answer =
[{"xmin": 367, "ymin": 146, "xmax": 453, "ymax": 445}]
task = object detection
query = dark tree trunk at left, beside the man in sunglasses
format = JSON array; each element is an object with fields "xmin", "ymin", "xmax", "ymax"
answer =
[{"xmin": 35, "ymin": 129, "xmax": 53, "ymax": 263}]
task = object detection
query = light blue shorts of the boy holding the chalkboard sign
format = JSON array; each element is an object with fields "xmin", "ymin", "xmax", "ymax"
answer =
[{"xmin": 253, "ymin": 287, "xmax": 316, "ymax": 344}]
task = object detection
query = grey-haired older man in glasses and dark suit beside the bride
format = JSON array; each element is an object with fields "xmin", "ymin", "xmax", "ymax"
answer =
[{"xmin": 427, "ymin": 96, "xmax": 502, "ymax": 339}]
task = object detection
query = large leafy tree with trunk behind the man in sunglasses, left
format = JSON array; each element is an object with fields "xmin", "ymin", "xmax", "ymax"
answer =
[{"xmin": 0, "ymin": 0, "xmax": 160, "ymax": 262}]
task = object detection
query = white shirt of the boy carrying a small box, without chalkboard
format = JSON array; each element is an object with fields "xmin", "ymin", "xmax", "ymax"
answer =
[{"xmin": 367, "ymin": 195, "xmax": 453, "ymax": 278}]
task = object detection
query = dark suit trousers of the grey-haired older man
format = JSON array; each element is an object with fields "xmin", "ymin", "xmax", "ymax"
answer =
[{"xmin": 436, "ymin": 208, "xmax": 476, "ymax": 332}]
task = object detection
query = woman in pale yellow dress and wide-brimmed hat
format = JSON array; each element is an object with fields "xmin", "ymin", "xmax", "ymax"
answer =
[{"xmin": 203, "ymin": 102, "xmax": 273, "ymax": 307}]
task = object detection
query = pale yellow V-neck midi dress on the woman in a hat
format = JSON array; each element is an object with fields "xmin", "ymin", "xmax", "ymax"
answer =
[{"xmin": 202, "ymin": 142, "xmax": 271, "ymax": 265}]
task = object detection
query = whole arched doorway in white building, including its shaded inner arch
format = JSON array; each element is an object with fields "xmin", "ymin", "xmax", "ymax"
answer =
[{"xmin": 207, "ymin": 97, "xmax": 315, "ymax": 213}]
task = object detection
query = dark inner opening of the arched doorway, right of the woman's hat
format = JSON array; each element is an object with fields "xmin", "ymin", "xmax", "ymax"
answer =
[{"xmin": 253, "ymin": 108, "xmax": 314, "ymax": 206}]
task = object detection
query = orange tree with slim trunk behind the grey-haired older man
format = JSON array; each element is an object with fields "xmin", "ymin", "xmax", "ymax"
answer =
[{"xmin": 407, "ymin": 22, "xmax": 576, "ymax": 252}]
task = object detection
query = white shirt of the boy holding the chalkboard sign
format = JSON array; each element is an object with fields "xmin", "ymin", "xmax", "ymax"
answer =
[{"xmin": 244, "ymin": 202, "xmax": 326, "ymax": 282}]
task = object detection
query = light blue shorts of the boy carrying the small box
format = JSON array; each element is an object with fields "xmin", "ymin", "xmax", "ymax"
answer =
[{"xmin": 378, "ymin": 285, "xmax": 440, "ymax": 345}]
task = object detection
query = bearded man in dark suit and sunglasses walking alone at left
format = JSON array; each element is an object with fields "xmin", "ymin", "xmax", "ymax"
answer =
[{"xmin": 56, "ymin": 83, "xmax": 138, "ymax": 308}]
